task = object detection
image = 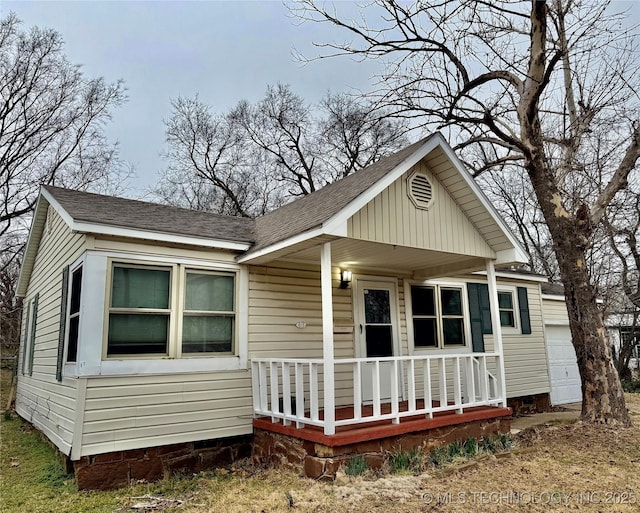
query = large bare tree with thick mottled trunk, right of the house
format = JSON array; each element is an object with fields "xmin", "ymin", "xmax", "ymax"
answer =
[{"xmin": 294, "ymin": 0, "xmax": 640, "ymax": 424}]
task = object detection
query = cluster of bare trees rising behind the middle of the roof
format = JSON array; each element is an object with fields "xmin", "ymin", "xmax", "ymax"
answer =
[{"xmin": 159, "ymin": 84, "xmax": 407, "ymax": 216}]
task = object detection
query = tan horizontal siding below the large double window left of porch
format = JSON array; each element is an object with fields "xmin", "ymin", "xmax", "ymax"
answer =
[{"xmin": 81, "ymin": 371, "xmax": 253, "ymax": 456}]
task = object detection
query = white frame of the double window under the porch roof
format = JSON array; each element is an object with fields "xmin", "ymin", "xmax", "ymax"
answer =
[{"xmin": 404, "ymin": 280, "xmax": 472, "ymax": 354}]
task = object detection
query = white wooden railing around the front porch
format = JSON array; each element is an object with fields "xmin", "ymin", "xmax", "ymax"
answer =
[{"xmin": 251, "ymin": 353, "xmax": 505, "ymax": 432}]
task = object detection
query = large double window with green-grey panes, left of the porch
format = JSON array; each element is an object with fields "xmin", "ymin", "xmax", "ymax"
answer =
[{"xmin": 107, "ymin": 263, "xmax": 236, "ymax": 358}]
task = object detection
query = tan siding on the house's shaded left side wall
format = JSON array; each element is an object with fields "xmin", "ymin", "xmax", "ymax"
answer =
[{"xmin": 16, "ymin": 207, "xmax": 85, "ymax": 454}]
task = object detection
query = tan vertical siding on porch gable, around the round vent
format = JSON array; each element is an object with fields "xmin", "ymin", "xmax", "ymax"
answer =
[{"xmin": 347, "ymin": 163, "xmax": 494, "ymax": 258}]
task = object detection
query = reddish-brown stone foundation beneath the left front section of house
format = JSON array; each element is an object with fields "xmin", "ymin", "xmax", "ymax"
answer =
[{"xmin": 73, "ymin": 435, "xmax": 252, "ymax": 490}]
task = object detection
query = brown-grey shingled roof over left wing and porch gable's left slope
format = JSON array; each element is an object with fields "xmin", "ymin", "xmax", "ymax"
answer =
[{"xmin": 43, "ymin": 137, "xmax": 436, "ymax": 251}]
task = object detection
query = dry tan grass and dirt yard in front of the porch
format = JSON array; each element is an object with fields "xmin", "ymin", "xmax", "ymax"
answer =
[{"xmin": 170, "ymin": 394, "xmax": 640, "ymax": 513}]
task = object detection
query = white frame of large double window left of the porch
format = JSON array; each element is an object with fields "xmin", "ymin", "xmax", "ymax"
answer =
[{"xmin": 102, "ymin": 258, "xmax": 241, "ymax": 362}]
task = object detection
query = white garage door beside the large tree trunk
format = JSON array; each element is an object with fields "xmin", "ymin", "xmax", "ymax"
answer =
[{"xmin": 545, "ymin": 325, "xmax": 582, "ymax": 405}]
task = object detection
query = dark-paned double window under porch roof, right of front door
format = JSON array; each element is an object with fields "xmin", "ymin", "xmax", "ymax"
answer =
[{"xmin": 411, "ymin": 285, "xmax": 465, "ymax": 348}]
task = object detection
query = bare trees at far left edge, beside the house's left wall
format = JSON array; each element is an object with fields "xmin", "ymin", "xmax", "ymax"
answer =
[{"xmin": 0, "ymin": 13, "xmax": 130, "ymax": 356}]
